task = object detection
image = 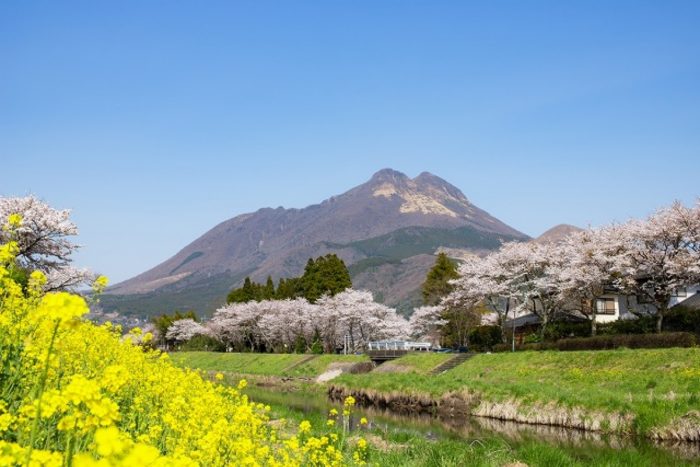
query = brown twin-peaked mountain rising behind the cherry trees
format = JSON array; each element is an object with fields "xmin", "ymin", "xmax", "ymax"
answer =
[{"xmin": 101, "ymin": 169, "xmax": 528, "ymax": 316}]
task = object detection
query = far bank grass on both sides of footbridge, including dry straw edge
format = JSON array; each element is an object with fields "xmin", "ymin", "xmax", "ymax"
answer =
[{"xmin": 173, "ymin": 347, "xmax": 700, "ymax": 441}]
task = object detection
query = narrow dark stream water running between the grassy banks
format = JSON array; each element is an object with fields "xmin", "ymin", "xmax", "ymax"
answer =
[{"xmin": 246, "ymin": 386, "xmax": 700, "ymax": 465}]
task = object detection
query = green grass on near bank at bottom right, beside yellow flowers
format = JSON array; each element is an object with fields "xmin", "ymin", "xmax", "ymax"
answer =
[{"xmin": 247, "ymin": 388, "xmax": 697, "ymax": 467}]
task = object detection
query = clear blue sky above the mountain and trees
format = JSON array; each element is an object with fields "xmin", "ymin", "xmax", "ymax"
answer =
[{"xmin": 0, "ymin": 0, "xmax": 700, "ymax": 280}]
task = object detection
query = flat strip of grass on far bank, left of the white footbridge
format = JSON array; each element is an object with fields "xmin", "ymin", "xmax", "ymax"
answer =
[{"xmin": 170, "ymin": 352, "xmax": 368, "ymax": 378}]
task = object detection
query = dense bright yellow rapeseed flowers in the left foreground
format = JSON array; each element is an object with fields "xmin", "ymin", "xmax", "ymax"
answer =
[{"xmin": 0, "ymin": 218, "xmax": 366, "ymax": 466}]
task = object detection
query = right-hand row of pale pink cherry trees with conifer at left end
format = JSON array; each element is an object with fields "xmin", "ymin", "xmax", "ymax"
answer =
[{"xmin": 422, "ymin": 201, "xmax": 700, "ymax": 350}]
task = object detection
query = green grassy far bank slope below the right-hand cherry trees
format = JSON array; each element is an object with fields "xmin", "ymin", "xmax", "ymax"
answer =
[{"xmin": 333, "ymin": 348, "xmax": 700, "ymax": 433}]
